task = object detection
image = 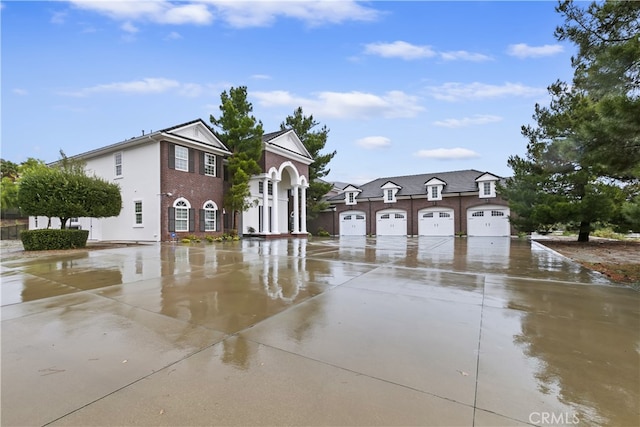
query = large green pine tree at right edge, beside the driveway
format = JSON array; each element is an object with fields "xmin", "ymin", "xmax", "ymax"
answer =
[{"xmin": 503, "ymin": 1, "xmax": 640, "ymax": 242}]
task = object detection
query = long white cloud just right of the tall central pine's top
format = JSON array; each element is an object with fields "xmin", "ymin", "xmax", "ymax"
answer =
[{"xmin": 253, "ymin": 91, "xmax": 424, "ymax": 119}]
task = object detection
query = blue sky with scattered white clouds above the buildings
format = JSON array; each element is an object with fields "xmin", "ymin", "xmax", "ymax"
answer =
[{"xmin": 0, "ymin": 0, "xmax": 575, "ymax": 184}]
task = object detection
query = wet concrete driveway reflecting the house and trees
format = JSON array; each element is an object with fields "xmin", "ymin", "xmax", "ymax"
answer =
[{"xmin": 1, "ymin": 237, "xmax": 640, "ymax": 426}]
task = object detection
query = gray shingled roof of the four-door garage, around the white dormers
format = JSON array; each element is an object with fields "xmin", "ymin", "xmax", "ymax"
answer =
[{"xmin": 328, "ymin": 169, "xmax": 497, "ymax": 200}]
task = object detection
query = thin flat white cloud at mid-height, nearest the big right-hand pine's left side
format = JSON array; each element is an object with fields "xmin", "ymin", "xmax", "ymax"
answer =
[{"xmin": 427, "ymin": 82, "xmax": 546, "ymax": 101}]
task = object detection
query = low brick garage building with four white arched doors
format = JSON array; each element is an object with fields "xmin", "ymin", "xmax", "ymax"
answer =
[{"xmin": 309, "ymin": 169, "xmax": 512, "ymax": 236}]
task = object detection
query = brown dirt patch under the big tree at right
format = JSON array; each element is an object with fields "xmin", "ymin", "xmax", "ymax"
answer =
[{"xmin": 538, "ymin": 239, "xmax": 640, "ymax": 287}]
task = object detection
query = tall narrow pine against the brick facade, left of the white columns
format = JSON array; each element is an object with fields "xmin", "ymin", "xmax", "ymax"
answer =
[{"xmin": 209, "ymin": 86, "xmax": 264, "ymax": 232}]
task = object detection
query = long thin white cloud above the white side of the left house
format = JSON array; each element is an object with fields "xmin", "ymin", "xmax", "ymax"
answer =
[{"xmin": 62, "ymin": 78, "xmax": 202, "ymax": 97}]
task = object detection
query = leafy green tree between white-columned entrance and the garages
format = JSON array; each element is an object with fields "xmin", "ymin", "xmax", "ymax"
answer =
[{"xmin": 280, "ymin": 107, "xmax": 336, "ymax": 220}]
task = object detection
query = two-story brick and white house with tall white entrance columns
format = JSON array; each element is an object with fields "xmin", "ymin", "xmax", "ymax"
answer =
[{"xmin": 29, "ymin": 119, "xmax": 313, "ymax": 242}]
